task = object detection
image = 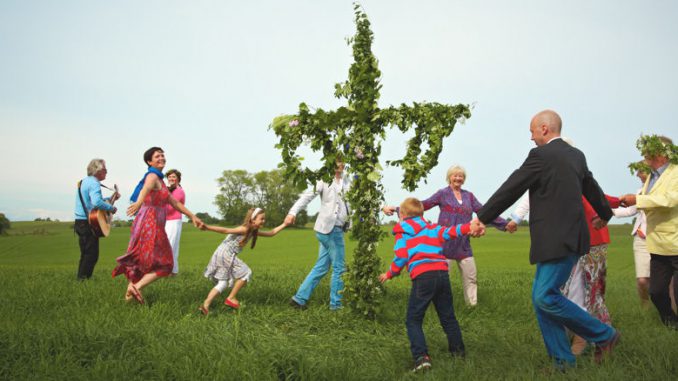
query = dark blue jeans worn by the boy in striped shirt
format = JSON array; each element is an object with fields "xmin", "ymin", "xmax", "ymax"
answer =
[{"xmin": 405, "ymin": 271, "xmax": 464, "ymax": 360}]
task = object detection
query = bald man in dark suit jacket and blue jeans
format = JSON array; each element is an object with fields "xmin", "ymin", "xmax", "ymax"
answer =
[{"xmin": 477, "ymin": 110, "xmax": 619, "ymax": 370}]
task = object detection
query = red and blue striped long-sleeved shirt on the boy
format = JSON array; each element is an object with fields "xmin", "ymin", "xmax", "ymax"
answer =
[{"xmin": 387, "ymin": 217, "xmax": 471, "ymax": 279}]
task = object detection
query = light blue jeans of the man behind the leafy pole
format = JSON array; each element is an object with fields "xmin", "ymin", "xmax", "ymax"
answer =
[{"xmin": 292, "ymin": 226, "xmax": 346, "ymax": 309}]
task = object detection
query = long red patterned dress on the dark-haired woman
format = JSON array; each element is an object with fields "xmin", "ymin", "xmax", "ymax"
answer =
[{"xmin": 113, "ymin": 184, "xmax": 174, "ymax": 283}]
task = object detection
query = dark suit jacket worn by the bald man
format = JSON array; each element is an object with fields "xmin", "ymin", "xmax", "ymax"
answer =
[{"xmin": 477, "ymin": 139, "xmax": 612, "ymax": 264}]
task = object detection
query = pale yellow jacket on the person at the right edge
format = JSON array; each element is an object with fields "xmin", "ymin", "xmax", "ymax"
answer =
[{"xmin": 636, "ymin": 164, "xmax": 678, "ymax": 255}]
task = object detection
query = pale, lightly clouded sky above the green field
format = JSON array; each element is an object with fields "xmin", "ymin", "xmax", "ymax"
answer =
[{"xmin": 0, "ymin": 0, "xmax": 678, "ymax": 222}]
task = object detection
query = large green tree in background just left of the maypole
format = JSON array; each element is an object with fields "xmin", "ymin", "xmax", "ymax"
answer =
[{"xmin": 214, "ymin": 169, "xmax": 308, "ymax": 227}]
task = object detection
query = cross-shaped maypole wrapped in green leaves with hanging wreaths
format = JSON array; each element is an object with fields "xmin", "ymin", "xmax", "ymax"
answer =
[{"xmin": 270, "ymin": 4, "xmax": 471, "ymax": 318}]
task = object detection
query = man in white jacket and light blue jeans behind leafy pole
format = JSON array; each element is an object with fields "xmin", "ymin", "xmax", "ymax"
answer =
[{"xmin": 285, "ymin": 162, "xmax": 351, "ymax": 310}]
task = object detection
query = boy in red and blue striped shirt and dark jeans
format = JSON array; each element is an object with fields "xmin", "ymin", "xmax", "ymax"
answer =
[{"xmin": 379, "ymin": 197, "xmax": 485, "ymax": 372}]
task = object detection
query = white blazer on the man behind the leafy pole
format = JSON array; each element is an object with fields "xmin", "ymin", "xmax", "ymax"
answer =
[{"xmin": 288, "ymin": 175, "xmax": 351, "ymax": 234}]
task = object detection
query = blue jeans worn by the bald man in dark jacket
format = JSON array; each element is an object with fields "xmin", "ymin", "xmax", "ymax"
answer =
[{"xmin": 532, "ymin": 255, "xmax": 615, "ymax": 365}]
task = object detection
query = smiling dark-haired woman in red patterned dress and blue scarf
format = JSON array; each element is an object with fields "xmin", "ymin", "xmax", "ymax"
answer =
[{"xmin": 113, "ymin": 147, "xmax": 203, "ymax": 304}]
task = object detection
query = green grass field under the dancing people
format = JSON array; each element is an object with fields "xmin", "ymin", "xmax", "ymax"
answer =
[{"xmin": 0, "ymin": 222, "xmax": 678, "ymax": 380}]
